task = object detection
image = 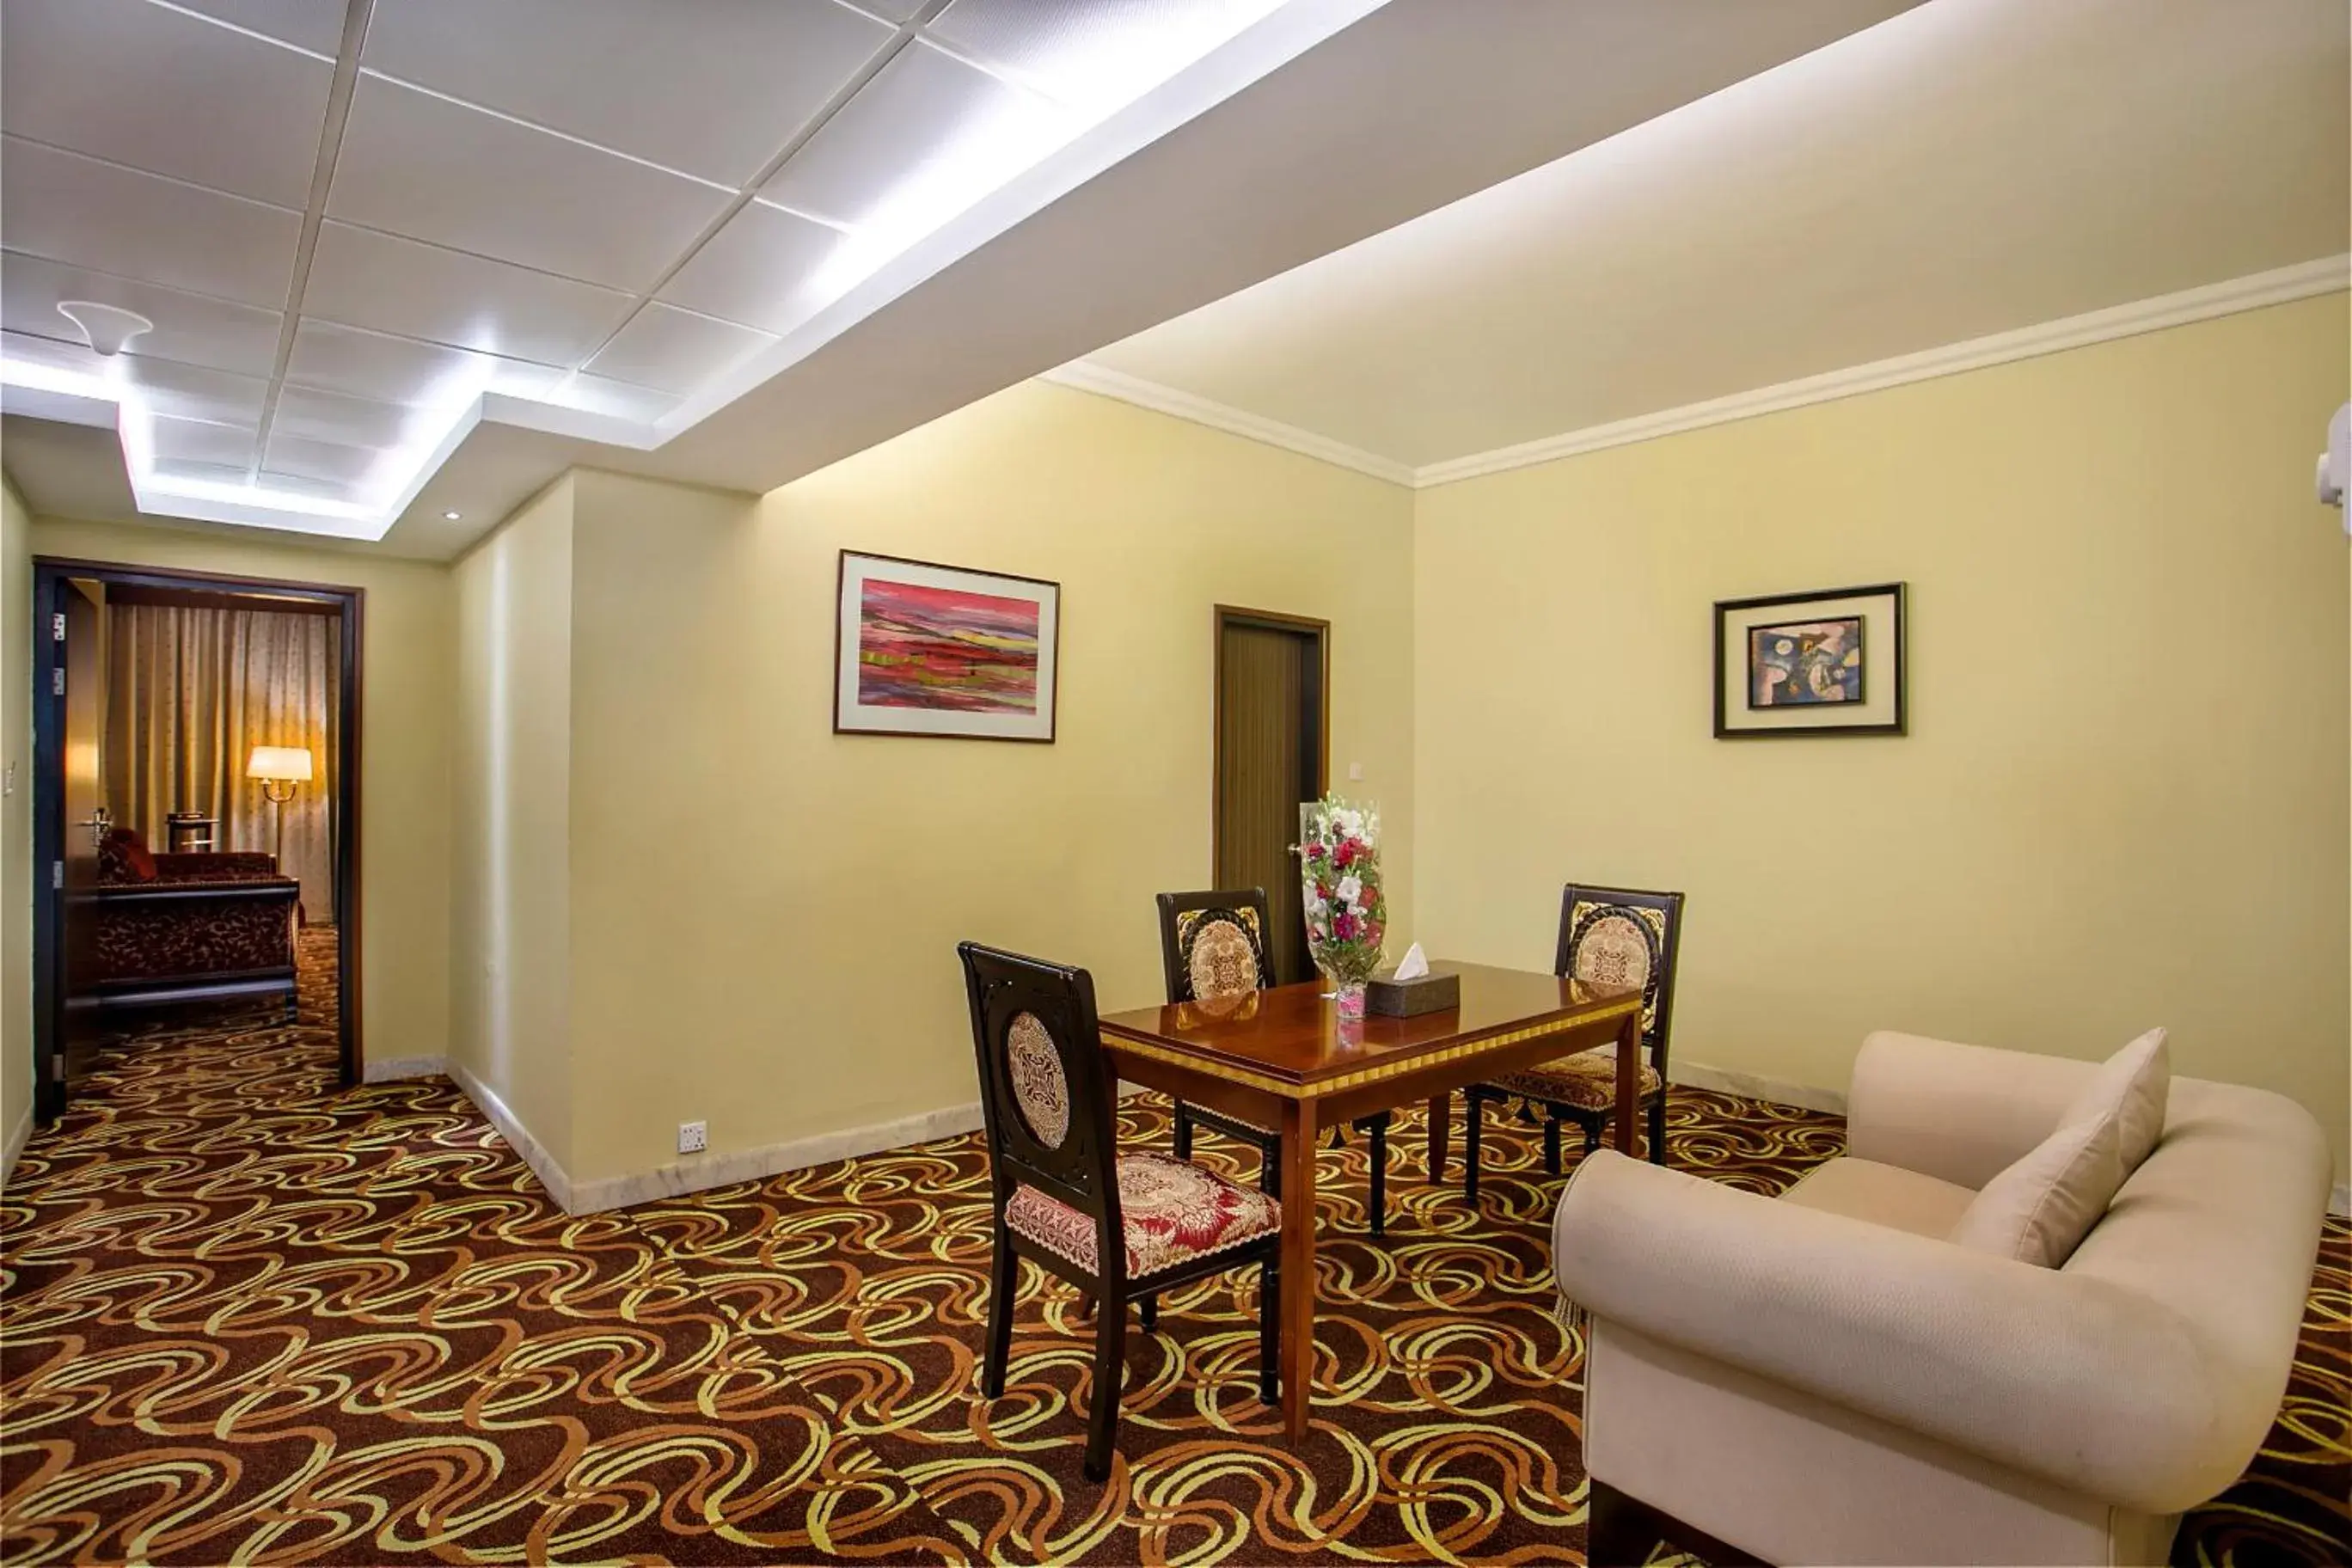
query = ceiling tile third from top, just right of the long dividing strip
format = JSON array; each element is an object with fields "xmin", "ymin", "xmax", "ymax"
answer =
[{"xmin": 301, "ymin": 224, "xmax": 633, "ymax": 367}]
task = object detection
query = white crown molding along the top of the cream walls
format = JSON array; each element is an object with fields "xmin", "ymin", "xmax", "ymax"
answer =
[{"xmin": 1044, "ymin": 254, "xmax": 2352, "ymax": 489}]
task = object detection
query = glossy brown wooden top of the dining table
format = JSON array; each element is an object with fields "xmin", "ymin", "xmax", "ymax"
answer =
[{"xmin": 1100, "ymin": 961, "xmax": 1639, "ymax": 1086}]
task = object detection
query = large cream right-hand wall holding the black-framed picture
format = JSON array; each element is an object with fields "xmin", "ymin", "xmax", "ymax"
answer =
[{"xmin": 1413, "ymin": 294, "xmax": 2352, "ymax": 1175}]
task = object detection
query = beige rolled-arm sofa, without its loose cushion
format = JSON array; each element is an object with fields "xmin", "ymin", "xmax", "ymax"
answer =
[{"xmin": 1553, "ymin": 1034, "xmax": 2329, "ymax": 1564}]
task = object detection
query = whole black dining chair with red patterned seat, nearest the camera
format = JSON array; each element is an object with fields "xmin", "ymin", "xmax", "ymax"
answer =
[{"xmin": 955, "ymin": 943, "xmax": 1314, "ymax": 1481}]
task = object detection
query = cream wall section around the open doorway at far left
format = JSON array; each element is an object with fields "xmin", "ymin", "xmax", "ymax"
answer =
[{"xmin": 26, "ymin": 518, "xmax": 454, "ymax": 1060}]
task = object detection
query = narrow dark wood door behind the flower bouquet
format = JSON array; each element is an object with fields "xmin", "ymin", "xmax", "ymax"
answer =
[{"xmin": 1211, "ymin": 604, "xmax": 1332, "ymax": 985}]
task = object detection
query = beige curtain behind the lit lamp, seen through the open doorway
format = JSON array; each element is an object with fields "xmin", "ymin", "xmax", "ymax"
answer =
[{"xmin": 106, "ymin": 604, "xmax": 341, "ymax": 926}]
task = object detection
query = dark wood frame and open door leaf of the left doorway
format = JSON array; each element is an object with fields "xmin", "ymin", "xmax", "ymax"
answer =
[{"xmin": 33, "ymin": 557, "xmax": 367, "ymax": 1121}]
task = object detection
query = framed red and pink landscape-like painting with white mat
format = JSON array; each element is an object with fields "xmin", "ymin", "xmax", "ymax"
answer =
[{"xmin": 833, "ymin": 550, "xmax": 1061, "ymax": 740}]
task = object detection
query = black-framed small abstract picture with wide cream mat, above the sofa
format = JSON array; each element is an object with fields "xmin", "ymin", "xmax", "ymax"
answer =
[{"xmin": 1715, "ymin": 583, "xmax": 1902, "ymax": 740}]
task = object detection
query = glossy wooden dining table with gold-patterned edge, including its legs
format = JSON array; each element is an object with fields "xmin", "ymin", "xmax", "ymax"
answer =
[{"xmin": 1100, "ymin": 964, "xmax": 1642, "ymax": 1441}]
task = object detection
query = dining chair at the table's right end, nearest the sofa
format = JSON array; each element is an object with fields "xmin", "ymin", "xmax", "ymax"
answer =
[{"xmin": 1463, "ymin": 881, "xmax": 1681, "ymax": 1197}]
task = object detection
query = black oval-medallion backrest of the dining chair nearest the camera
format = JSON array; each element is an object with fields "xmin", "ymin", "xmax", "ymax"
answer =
[{"xmin": 955, "ymin": 943, "xmax": 1124, "ymax": 1258}]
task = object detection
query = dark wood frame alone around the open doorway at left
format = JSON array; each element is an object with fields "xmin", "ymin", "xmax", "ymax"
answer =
[{"xmin": 31, "ymin": 554, "xmax": 367, "ymax": 1124}]
